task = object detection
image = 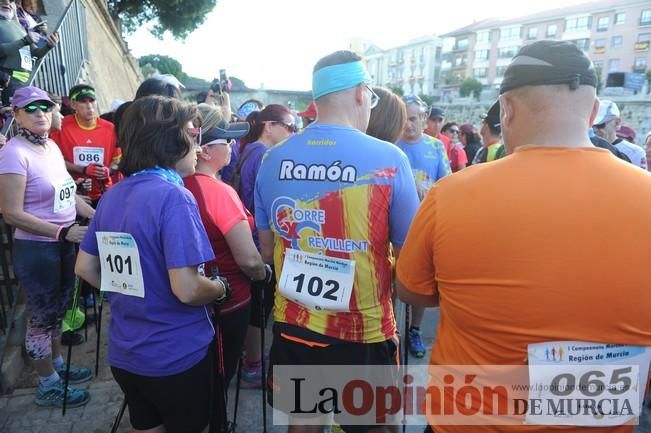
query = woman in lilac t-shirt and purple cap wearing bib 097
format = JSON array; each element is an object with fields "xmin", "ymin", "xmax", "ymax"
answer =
[{"xmin": 0, "ymin": 87, "xmax": 95, "ymax": 407}]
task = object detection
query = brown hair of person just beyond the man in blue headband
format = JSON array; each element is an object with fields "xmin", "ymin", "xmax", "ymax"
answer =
[{"xmin": 366, "ymin": 87, "xmax": 407, "ymax": 143}]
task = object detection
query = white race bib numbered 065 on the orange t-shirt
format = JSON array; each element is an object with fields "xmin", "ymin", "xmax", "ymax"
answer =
[{"xmin": 526, "ymin": 341, "xmax": 651, "ymax": 427}]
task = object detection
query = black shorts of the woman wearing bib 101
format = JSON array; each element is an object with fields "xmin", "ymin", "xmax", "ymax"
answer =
[{"xmin": 111, "ymin": 343, "xmax": 214, "ymax": 433}]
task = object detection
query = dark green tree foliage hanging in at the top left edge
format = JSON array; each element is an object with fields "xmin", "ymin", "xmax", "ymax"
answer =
[{"xmin": 107, "ymin": 0, "xmax": 217, "ymax": 39}]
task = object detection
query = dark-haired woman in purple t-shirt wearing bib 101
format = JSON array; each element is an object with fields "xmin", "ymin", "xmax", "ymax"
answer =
[{"xmin": 75, "ymin": 96, "xmax": 228, "ymax": 433}]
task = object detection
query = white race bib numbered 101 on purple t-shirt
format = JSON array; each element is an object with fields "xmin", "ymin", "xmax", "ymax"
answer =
[{"xmin": 95, "ymin": 232, "xmax": 145, "ymax": 298}]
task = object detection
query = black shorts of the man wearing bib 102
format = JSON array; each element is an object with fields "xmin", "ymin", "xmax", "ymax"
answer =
[{"xmin": 267, "ymin": 327, "xmax": 399, "ymax": 433}]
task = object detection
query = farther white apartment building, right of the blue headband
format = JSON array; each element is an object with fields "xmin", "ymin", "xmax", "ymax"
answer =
[{"xmin": 364, "ymin": 35, "xmax": 442, "ymax": 97}]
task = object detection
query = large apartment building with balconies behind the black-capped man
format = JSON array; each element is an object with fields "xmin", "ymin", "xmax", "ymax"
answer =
[{"xmin": 441, "ymin": 0, "xmax": 651, "ymax": 97}]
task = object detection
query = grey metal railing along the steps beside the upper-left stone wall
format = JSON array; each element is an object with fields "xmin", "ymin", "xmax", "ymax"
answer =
[{"xmin": 2, "ymin": 0, "xmax": 88, "ymax": 135}]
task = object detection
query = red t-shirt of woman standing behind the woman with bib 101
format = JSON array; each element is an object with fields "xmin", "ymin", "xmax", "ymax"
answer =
[{"xmin": 183, "ymin": 173, "xmax": 255, "ymax": 313}]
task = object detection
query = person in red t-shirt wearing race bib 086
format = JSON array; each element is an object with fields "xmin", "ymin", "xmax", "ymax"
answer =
[{"xmin": 50, "ymin": 84, "xmax": 121, "ymax": 206}]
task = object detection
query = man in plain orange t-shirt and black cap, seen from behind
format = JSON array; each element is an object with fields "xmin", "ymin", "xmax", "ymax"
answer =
[{"xmin": 397, "ymin": 41, "xmax": 651, "ymax": 433}]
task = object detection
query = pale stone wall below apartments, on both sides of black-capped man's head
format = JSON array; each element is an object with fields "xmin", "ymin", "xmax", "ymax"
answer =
[{"xmin": 440, "ymin": 97, "xmax": 651, "ymax": 142}]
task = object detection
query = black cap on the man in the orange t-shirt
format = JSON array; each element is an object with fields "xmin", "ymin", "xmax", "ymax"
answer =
[{"xmin": 500, "ymin": 40, "xmax": 597, "ymax": 94}]
